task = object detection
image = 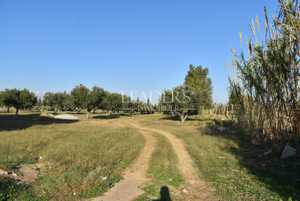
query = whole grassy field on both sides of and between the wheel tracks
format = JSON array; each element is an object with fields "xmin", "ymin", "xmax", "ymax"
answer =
[{"xmin": 0, "ymin": 114, "xmax": 300, "ymax": 201}]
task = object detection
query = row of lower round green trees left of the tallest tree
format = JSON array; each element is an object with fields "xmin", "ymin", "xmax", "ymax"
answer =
[{"xmin": 0, "ymin": 84, "xmax": 155, "ymax": 114}]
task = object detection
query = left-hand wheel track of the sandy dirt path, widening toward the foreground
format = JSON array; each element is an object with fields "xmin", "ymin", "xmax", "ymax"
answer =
[{"xmin": 91, "ymin": 123, "xmax": 155, "ymax": 201}]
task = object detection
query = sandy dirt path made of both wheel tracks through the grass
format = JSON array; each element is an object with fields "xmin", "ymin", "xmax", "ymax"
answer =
[{"xmin": 90, "ymin": 120, "xmax": 215, "ymax": 201}]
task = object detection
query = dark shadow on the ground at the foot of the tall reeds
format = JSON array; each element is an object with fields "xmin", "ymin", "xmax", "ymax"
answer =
[{"xmin": 201, "ymin": 122, "xmax": 300, "ymax": 200}]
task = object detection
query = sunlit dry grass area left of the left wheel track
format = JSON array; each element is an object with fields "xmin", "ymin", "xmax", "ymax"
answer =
[{"xmin": 0, "ymin": 114, "xmax": 144, "ymax": 200}]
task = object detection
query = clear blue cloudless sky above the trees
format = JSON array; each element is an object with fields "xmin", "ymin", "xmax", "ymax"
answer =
[{"xmin": 0, "ymin": 0, "xmax": 277, "ymax": 102}]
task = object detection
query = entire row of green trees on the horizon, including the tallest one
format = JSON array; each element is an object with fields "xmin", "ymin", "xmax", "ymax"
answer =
[{"xmin": 0, "ymin": 65, "xmax": 212, "ymax": 121}]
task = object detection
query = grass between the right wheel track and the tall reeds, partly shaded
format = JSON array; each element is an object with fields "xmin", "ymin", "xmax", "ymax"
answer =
[{"xmin": 137, "ymin": 116, "xmax": 300, "ymax": 201}]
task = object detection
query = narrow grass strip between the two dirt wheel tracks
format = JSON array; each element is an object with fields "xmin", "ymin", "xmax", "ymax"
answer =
[{"xmin": 137, "ymin": 134, "xmax": 184, "ymax": 201}]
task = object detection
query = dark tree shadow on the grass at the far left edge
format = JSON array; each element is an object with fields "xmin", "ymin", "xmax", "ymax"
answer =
[{"xmin": 0, "ymin": 114, "xmax": 77, "ymax": 131}]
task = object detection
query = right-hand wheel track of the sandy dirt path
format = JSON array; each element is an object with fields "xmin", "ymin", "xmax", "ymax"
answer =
[{"xmin": 131, "ymin": 122, "xmax": 214, "ymax": 201}]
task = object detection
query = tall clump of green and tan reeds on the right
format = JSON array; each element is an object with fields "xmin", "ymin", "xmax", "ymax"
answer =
[{"xmin": 229, "ymin": 0, "xmax": 300, "ymax": 142}]
